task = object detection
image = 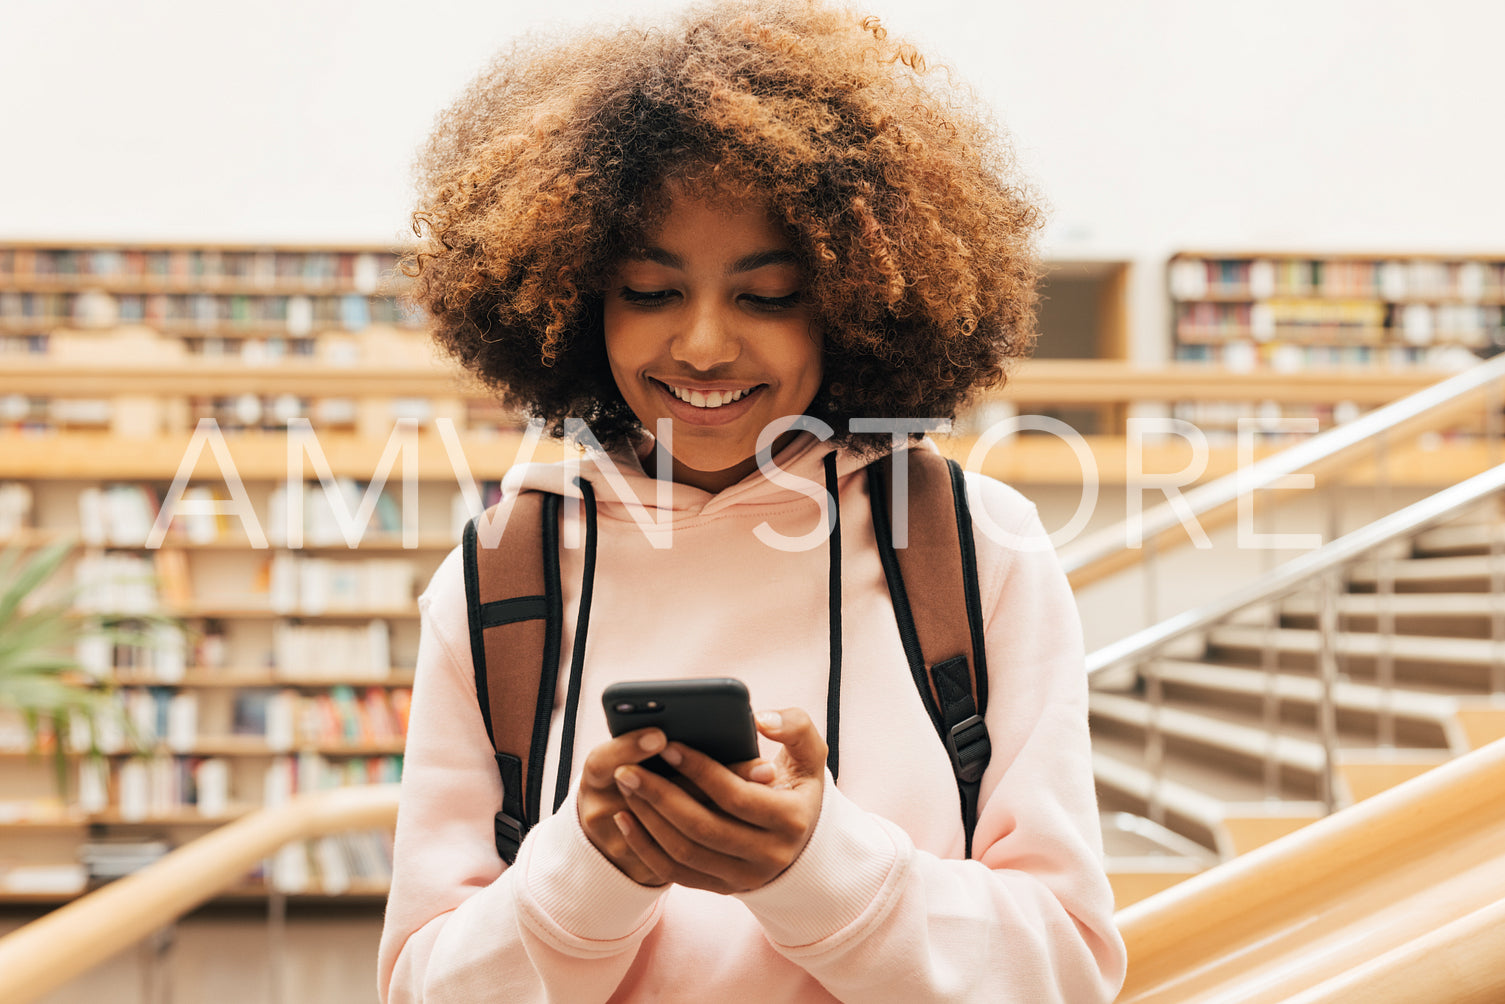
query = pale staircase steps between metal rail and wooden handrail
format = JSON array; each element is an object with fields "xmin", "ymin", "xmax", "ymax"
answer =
[{"xmin": 1090, "ymin": 501, "xmax": 1505, "ymax": 906}]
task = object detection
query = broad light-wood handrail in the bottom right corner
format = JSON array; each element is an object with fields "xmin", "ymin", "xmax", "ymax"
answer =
[{"xmin": 1118, "ymin": 741, "xmax": 1505, "ymax": 1004}]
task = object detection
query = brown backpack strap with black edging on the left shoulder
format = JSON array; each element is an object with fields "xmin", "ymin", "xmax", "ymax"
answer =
[{"xmin": 461, "ymin": 492, "xmax": 563, "ymax": 864}]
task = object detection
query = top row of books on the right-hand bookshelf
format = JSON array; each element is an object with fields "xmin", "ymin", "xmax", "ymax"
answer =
[{"xmin": 1169, "ymin": 256, "xmax": 1505, "ymax": 303}]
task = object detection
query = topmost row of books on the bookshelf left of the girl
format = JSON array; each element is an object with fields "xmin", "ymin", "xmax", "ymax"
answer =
[{"xmin": 0, "ymin": 247, "xmax": 400, "ymax": 292}]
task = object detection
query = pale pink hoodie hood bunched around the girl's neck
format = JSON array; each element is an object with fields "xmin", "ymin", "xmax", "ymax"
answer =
[{"xmin": 503, "ymin": 432, "xmax": 935, "ymax": 522}]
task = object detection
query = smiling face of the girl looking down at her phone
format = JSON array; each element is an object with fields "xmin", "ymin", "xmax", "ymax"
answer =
[{"xmin": 604, "ymin": 182, "xmax": 822, "ymax": 492}]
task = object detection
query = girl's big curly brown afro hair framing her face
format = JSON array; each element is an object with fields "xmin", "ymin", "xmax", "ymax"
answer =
[{"xmin": 405, "ymin": 0, "xmax": 1041, "ymax": 453}]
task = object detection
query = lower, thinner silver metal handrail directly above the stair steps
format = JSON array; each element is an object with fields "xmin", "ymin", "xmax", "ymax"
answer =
[{"xmin": 1087, "ymin": 460, "xmax": 1505, "ymax": 677}]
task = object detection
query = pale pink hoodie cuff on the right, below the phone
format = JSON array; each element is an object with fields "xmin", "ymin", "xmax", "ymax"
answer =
[{"xmin": 737, "ymin": 771, "xmax": 905, "ymax": 948}]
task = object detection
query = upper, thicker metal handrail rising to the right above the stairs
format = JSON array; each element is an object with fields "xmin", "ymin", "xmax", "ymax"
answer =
[{"xmin": 1061, "ymin": 354, "xmax": 1505, "ymax": 586}]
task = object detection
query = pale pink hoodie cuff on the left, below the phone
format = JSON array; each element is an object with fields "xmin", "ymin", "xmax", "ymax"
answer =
[{"xmin": 515, "ymin": 792, "xmax": 668, "ymax": 941}]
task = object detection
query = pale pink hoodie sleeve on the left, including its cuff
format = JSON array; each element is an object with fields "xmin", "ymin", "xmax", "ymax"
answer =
[{"xmin": 378, "ymin": 552, "xmax": 661, "ymax": 1004}]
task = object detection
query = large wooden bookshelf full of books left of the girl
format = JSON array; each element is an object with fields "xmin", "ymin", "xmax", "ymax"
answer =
[{"xmin": 0, "ymin": 242, "xmax": 454, "ymax": 903}]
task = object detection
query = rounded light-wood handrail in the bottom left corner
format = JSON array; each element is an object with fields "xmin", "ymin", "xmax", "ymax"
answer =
[{"xmin": 0, "ymin": 784, "xmax": 397, "ymax": 1004}]
